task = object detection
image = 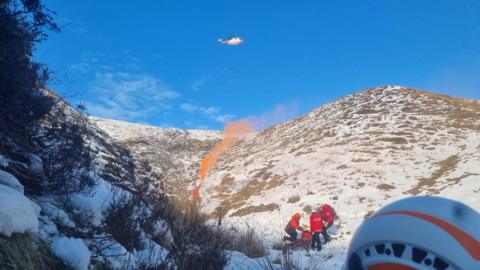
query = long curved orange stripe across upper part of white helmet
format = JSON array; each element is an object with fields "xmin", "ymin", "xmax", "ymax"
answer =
[{"xmin": 372, "ymin": 210, "xmax": 480, "ymax": 261}]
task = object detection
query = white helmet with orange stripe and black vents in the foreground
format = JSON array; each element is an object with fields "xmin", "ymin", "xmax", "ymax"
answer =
[{"xmin": 344, "ymin": 196, "xmax": 480, "ymax": 270}]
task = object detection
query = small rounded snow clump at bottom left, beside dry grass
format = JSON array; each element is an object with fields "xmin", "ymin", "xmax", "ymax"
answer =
[{"xmin": 52, "ymin": 237, "xmax": 91, "ymax": 270}]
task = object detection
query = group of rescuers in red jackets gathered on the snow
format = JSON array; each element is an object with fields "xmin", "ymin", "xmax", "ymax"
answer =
[{"xmin": 283, "ymin": 204, "xmax": 338, "ymax": 251}]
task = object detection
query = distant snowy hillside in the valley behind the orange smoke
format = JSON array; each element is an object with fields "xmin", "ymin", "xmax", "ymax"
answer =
[{"xmin": 90, "ymin": 117, "xmax": 222, "ymax": 198}]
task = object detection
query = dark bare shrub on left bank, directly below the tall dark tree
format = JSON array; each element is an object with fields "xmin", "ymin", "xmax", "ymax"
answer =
[{"xmin": 36, "ymin": 100, "xmax": 96, "ymax": 195}]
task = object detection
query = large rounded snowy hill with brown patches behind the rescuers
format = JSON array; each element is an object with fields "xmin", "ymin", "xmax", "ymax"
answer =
[{"xmin": 196, "ymin": 87, "xmax": 480, "ymax": 269}]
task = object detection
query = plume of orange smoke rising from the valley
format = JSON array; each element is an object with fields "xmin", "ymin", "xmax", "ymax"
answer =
[{"xmin": 192, "ymin": 120, "xmax": 253, "ymax": 198}]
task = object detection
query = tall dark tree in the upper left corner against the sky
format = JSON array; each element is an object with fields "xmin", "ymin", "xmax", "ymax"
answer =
[{"xmin": 0, "ymin": 0, "xmax": 59, "ymax": 146}]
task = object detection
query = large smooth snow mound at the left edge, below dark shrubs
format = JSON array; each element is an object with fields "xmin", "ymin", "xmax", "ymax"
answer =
[{"xmin": 0, "ymin": 185, "xmax": 38, "ymax": 237}]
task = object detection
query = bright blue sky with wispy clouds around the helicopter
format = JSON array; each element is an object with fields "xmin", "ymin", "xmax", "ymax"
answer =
[{"xmin": 36, "ymin": 0, "xmax": 480, "ymax": 129}]
